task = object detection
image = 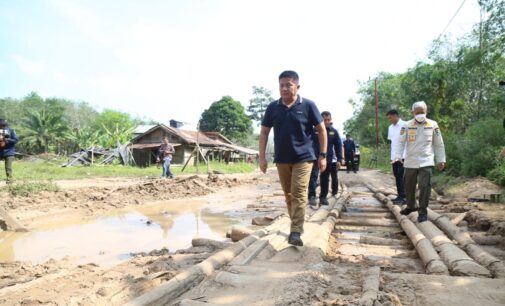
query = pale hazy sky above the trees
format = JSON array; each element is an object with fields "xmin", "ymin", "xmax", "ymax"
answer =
[{"xmin": 0, "ymin": 0, "xmax": 479, "ymax": 127}]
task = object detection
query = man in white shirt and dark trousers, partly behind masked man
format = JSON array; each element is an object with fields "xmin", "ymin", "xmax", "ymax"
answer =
[{"xmin": 387, "ymin": 109, "xmax": 407, "ymax": 204}]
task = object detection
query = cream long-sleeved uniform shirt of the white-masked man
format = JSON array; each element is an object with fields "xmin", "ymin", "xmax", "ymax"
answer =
[{"xmin": 394, "ymin": 119, "xmax": 445, "ymax": 169}]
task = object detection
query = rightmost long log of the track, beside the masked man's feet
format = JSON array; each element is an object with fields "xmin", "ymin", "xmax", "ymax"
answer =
[{"xmin": 428, "ymin": 210, "xmax": 505, "ymax": 278}]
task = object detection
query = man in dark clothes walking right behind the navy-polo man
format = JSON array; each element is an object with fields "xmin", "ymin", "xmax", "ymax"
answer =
[{"xmin": 309, "ymin": 111, "xmax": 342, "ymax": 207}]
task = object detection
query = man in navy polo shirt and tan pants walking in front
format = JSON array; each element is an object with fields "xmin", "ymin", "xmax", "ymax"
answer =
[{"xmin": 259, "ymin": 71, "xmax": 327, "ymax": 246}]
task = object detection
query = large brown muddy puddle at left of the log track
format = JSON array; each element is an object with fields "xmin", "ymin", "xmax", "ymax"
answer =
[{"xmin": 0, "ymin": 199, "xmax": 240, "ymax": 265}]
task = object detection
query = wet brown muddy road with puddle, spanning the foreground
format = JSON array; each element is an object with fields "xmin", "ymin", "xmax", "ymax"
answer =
[{"xmin": 0, "ymin": 169, "xmax": 505, "ymax": 305}]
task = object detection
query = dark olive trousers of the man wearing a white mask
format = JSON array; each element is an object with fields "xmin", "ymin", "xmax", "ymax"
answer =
[{"xmin": 404, "ymin": 167, "xmax": 433, "ymax": 214}]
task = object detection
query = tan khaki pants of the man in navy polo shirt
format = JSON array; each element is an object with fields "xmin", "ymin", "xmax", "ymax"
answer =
[{"xmin": 276, "ymin": 161, "xmax": 312, "ymax": 233}]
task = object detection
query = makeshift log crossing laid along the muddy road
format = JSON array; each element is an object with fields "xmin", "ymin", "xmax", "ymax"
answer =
[{"xmin": 128, "ymin": 178, "xmax": 505, "ymax": 306}]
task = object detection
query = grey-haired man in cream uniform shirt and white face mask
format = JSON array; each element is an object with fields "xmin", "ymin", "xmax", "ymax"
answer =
[{"xmin": 394, "ymin": 101, "xmax": 445, "ymax": 222}]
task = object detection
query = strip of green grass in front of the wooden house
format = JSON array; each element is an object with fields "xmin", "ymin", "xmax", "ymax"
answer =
[{"xmin": 0, "ymin": 158, "xmax": 257, "ymax": 182}]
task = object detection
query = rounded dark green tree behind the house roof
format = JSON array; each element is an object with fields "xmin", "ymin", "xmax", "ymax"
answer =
[{"xmin": 200, "ymin": 96, "xmax": 253, "ymax": 143}]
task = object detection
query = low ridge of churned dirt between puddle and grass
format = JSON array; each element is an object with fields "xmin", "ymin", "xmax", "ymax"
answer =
[{"xmin": 4, "ymin": 175, "xmax": 250, "ymax": 228}]
